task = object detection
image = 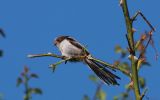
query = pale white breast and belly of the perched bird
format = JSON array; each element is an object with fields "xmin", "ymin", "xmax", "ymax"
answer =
[{"xmin": 59, "ymin": 40, "xmax": 82, "ymax": 57}]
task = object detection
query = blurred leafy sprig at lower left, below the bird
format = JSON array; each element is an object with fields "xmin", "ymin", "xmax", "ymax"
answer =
[{"xmin": 16, "ymin": 67, "xmax": 42, "ymax": 100}]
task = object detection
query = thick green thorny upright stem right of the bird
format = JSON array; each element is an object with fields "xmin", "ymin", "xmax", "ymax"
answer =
[{"xmin": 121, "ymin": 0, "xmax": 141, "ymax": 100}]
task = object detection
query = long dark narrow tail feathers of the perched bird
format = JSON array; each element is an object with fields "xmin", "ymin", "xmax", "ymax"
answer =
[{"xmin": 84, "ymin": 58, "xmax": 120, "ymax": 85}]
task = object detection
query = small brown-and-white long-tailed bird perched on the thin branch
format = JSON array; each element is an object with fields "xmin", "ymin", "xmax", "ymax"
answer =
[{"xmin": 53, "ymin": 36, "xmax": 120, "ymax": 85}]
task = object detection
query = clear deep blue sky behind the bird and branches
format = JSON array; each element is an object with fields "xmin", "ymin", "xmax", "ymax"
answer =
[{"xmin": 0, "ymin": 0, "xmax": 160, "ymax": 100}]
